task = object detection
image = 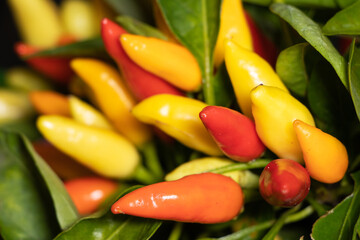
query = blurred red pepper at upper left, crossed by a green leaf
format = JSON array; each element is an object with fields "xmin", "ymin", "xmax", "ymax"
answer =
[{"xmin": 15, "ymin": 43, "xmax": 74, "ymax": 84}]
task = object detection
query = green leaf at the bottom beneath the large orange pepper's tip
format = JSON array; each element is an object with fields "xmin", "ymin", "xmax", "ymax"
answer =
[{"xmin": 55, "ymin": 186, "xmax": 162, "ymax": 240}]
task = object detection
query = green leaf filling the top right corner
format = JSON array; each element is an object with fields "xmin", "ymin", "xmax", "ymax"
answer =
[{"xmin": 322, "ymin": 1, "xmax": 360, "ymax": 35}]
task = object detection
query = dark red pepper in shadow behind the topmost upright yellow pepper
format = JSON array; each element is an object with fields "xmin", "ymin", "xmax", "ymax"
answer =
[{"xmin": 245, "ymin": 11, "xmax": 278, "ymax": 66}]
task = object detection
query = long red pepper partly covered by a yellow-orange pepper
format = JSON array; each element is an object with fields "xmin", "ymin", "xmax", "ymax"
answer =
[{"xmin": 101, "ymin": 18, "xmax": 184, "ymax": 101}]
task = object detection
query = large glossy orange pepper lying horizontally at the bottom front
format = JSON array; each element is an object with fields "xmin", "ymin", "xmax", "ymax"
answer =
[{"xmin": 111, "ymin": 173, "xmax": 243, "ymax": 224}]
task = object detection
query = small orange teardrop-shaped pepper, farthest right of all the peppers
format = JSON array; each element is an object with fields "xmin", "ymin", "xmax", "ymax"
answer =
[{"xmin": 293, "ymin": 120, "xmax": 349, "ymax": 184}]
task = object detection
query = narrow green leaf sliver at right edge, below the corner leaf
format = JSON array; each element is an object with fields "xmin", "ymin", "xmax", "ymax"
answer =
[{"xmin": 349, "ymin": 41, "xmax": 360, "ymax": 123}]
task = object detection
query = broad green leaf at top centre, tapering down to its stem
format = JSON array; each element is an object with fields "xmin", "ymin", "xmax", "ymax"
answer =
[{"xmin": 157, "ymin": 0, "xmax": 220, "ymax": 105}]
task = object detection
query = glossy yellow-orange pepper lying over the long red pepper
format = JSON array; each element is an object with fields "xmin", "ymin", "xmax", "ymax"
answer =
[{"xmin": 120, "ymin": 33, "xmax": 202, "ymax": 91}]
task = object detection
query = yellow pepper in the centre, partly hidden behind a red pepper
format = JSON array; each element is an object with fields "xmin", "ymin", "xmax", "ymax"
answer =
[{"xmin": 132, "ymin": 94, "xmax": 222, "ymax": 156}]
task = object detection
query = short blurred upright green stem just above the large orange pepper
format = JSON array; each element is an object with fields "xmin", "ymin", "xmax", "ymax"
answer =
[{"xmin": 142, "ymin": 142, "xmax": 164, "ymax": 179}]
